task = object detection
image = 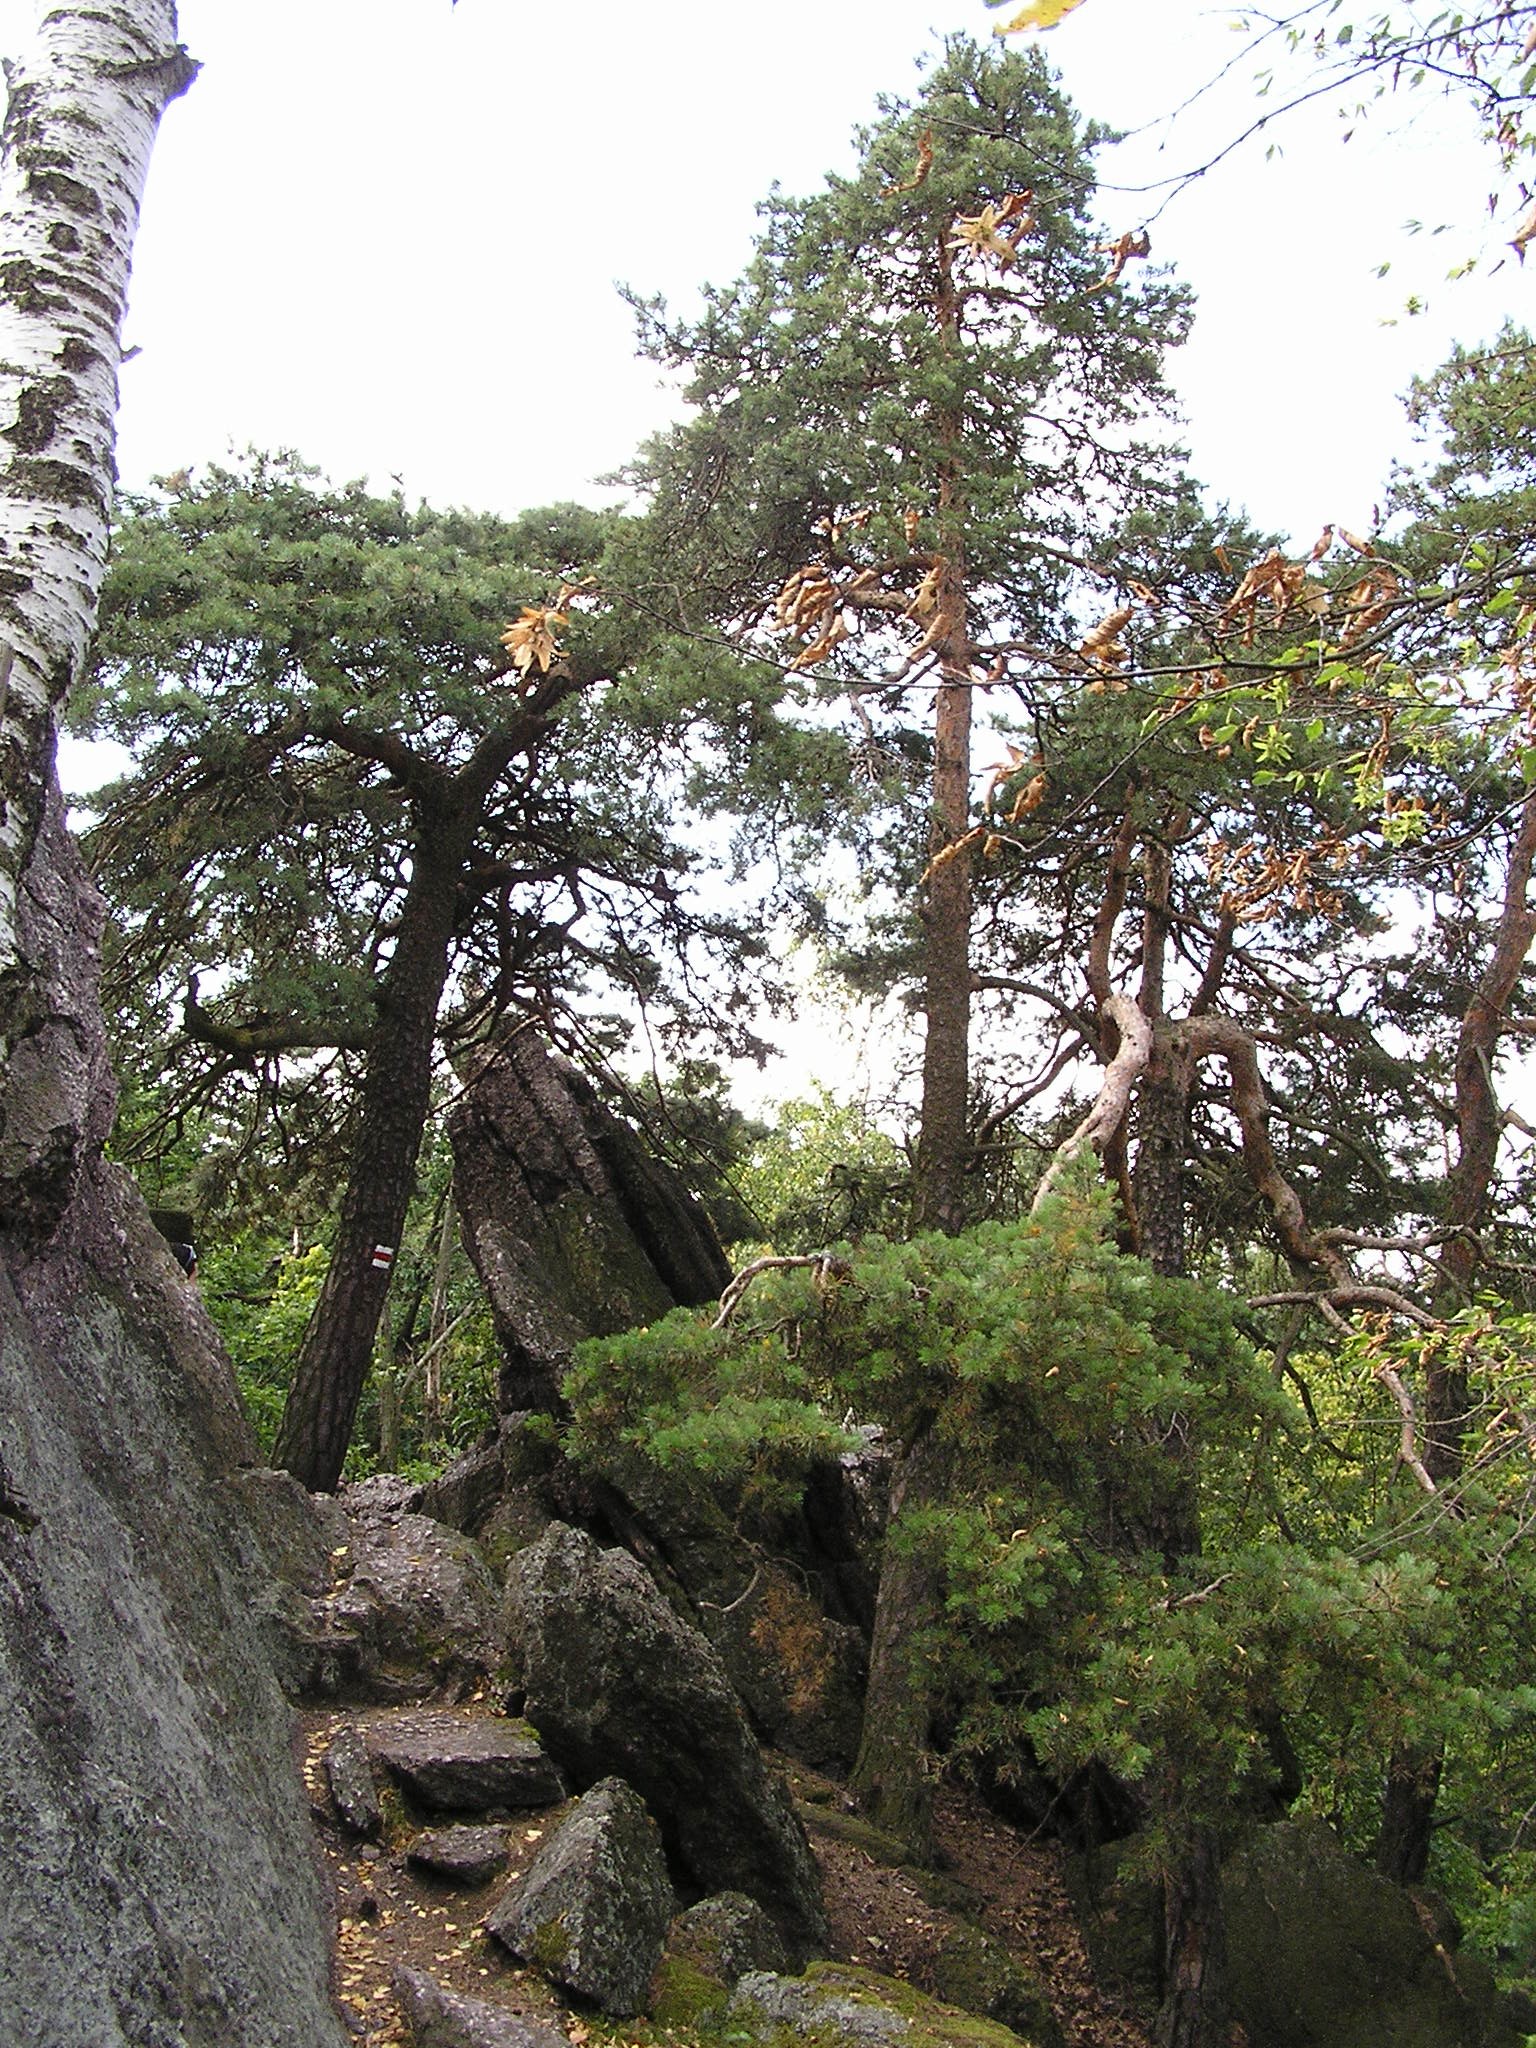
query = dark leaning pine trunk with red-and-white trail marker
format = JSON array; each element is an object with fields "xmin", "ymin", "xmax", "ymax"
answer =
[{"xmin": 272, "ymin": 805, "xmax": 471, "ymax": 1493}]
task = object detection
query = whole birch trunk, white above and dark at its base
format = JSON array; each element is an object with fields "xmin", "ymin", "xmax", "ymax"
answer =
[{"xmin": 0, "ymin": 0, "xmax": 197, "ymax": 1239}]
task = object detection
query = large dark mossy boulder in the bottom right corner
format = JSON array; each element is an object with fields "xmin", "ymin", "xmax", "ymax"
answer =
[{"xmin": 1223, "ymin": 1821, "xmax": 1522, "ymax": 2048}]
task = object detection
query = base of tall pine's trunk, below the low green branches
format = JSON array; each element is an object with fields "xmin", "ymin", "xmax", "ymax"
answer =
[{"xmin": 850, "ymin": 1427, "xmax": 948, "ymax": 1864}]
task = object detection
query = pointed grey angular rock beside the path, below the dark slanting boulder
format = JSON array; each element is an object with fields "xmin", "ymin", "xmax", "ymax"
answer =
[{"xmin": 485, "ymin": 1778, "xmax": 676, "ymax": 2019}]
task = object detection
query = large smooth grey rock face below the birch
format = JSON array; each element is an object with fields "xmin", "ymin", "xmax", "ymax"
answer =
[{"xmin": 0, "ymin": 1163, "xmax": 344, "ymax": 2048}]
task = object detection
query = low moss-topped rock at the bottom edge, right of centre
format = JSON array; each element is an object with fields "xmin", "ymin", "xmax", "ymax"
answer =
[{"xmin": 725, "ymin": 1962, "xmax": 1036, "ymax": 2048}]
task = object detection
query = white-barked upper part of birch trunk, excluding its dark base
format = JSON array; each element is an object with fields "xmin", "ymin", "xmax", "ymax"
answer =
[{"xmin": 0, "ymin": 0, "xmax": 197, "ymax": 999}]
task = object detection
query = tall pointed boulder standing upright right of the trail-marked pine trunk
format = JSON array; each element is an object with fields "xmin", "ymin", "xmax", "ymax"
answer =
[{"xmin": 449, "ymin": 1030, "xmax": 731, "ymax": 1413}]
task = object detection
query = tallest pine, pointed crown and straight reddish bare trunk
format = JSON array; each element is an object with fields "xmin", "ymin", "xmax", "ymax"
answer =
[{"xmin": 633, "ymin": 41, "xmax": 1188, "ymax": 1231}]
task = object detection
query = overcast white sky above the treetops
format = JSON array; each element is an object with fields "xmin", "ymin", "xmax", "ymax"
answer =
[{"xmin": 15, "ymin": 0, "xmax": 1536, "ymax": 539}]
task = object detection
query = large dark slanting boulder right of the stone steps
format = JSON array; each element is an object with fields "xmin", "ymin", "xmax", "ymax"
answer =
[{"xmin": 506, "ymin": 1524, "xmax": 829, "ymax": 1962}]
